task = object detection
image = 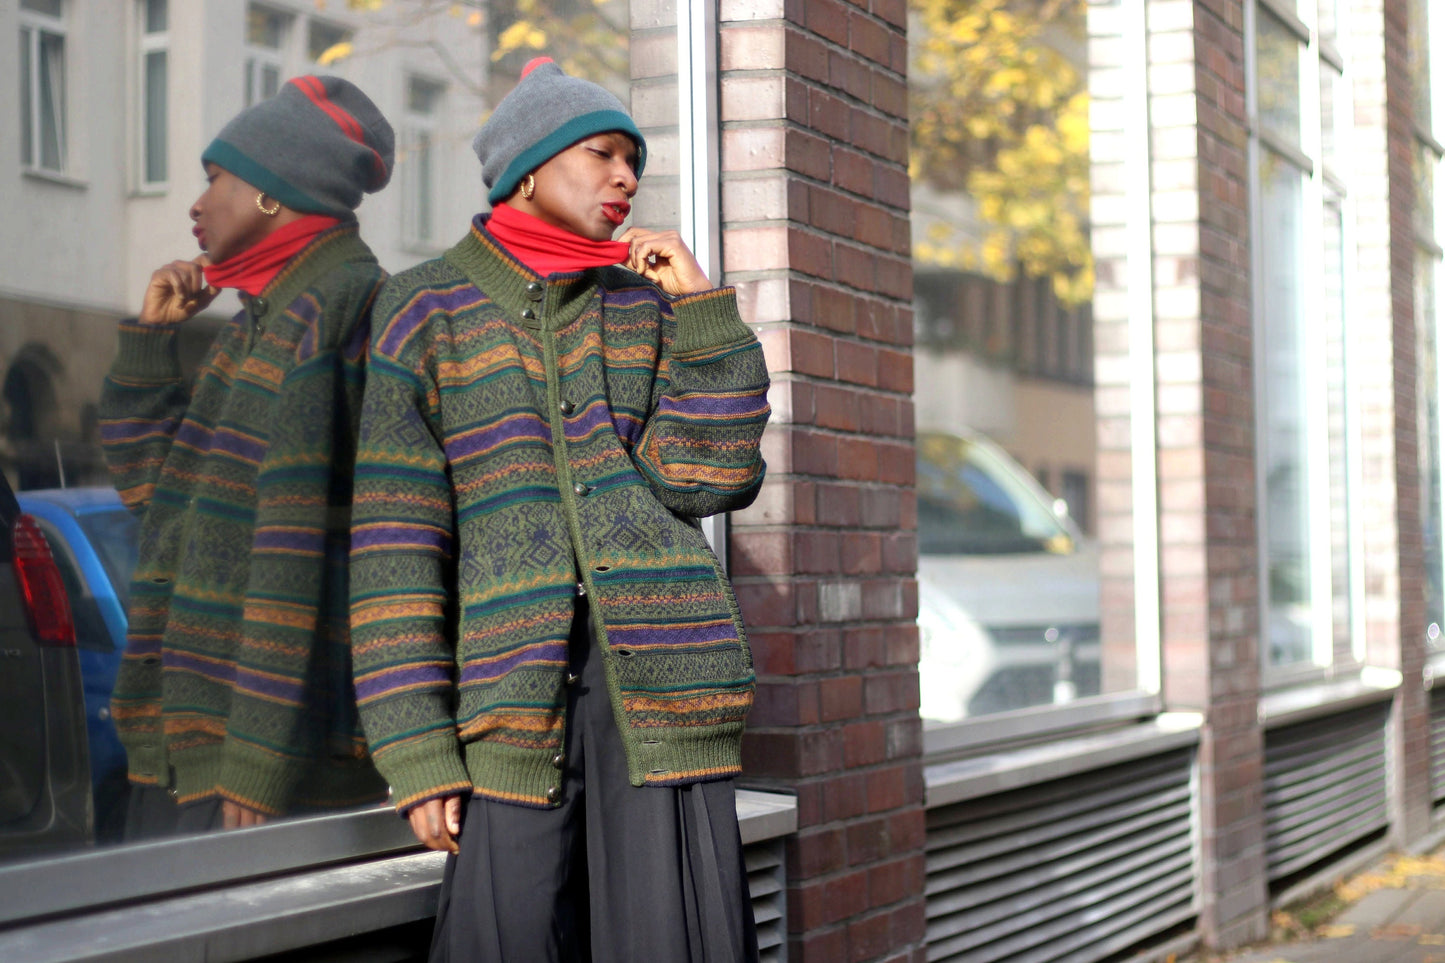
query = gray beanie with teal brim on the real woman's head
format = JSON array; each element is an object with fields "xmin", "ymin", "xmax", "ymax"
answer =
[{"xmin": 471, "ymin": 56, "xmax": 647, "ymax": 204}]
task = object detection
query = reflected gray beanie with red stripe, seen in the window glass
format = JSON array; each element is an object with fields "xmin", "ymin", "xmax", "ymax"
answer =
[{"xmin": 201, "ymin": 77, "xmax": 394, "ymax": 218}]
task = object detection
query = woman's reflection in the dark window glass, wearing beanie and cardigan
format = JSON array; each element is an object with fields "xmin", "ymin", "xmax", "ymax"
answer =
[{"xmin": 101, "ymin": 77, "xmax": 393, "ymax": 836}]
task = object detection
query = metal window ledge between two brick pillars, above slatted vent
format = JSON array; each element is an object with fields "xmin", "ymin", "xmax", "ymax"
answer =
[{"xmin": 923, "ymin": 713, "xmax": 1204, "ymax": 808}]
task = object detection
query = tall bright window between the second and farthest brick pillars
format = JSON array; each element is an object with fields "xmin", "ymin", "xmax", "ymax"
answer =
[{"xmin": 1248, "ymin": 0, "xmax": 1363, "ymax": 673}]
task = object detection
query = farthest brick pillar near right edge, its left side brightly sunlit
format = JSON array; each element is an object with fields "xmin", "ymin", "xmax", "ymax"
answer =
[{"xmin": 1342, "ymin": 0, "xmax": 1431, "ymax": 844}]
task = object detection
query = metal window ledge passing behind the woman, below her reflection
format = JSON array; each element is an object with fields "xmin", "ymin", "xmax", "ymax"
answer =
[{"xmin": 0, "ymin": 789, "xmax": 798, "ymax": 963}]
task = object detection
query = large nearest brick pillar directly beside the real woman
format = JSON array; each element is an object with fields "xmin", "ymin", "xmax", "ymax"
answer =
[{"xmin": 718, "ymin": 0, "xmax": 923, "ymax": 963}]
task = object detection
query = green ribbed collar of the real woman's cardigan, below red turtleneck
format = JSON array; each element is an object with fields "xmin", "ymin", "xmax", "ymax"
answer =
[{"xmin": 442, "ymin": 214, "xmax": 601, "ymax": 331}]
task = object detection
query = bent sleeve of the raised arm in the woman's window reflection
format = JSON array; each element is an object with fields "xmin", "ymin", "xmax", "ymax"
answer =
[{"xmin": 100, "ymin": 321, "xmax": 191, "ymax": 512}]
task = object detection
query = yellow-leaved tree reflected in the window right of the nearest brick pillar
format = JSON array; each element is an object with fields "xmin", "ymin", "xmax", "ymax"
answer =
[{"xmin": 909, "ymin": 0, "xmax": 1094, "ymax": 305}]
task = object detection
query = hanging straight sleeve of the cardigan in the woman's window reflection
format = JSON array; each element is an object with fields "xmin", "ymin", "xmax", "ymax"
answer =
[{"xmin": 218, "ymin": 305, "xmax": 370, "ymax": 813}]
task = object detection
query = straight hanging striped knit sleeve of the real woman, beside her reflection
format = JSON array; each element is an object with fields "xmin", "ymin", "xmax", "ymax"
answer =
[{"xmin": 351, "ymin": 292, "xmax": 471, "ymax": 811}]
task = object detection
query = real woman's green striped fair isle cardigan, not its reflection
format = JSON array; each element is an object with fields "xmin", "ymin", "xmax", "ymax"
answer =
[{"xmin": 351, "ymin": 224, "xmax": 769, "ymax": 811}]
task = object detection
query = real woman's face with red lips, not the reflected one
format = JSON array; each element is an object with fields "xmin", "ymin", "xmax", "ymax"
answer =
[{"xmin": 507, "ymin": 132, "xmax": 637, "ymax": 241}]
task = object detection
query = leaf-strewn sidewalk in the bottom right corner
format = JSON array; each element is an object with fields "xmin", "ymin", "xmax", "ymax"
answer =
[{"xmin": 1188, "ymin": 849, "xmax": 1445, "ymax": 963}]
